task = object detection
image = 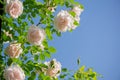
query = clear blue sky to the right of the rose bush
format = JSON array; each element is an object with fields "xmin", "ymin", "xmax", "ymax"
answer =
[{"xmin": 50, "ymin": 0, "xmax": 120, "ymax": 80}]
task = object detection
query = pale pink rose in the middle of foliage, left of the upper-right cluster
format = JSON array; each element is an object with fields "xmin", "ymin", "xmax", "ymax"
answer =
[{"xmin": 27, "ymin": 25, "xmax": 45, "ymax": 45}]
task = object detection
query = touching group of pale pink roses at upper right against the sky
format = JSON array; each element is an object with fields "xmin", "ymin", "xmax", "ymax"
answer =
[{"xmin": 54, "ymin": 6, "xmax": 83, "ymax": 32}]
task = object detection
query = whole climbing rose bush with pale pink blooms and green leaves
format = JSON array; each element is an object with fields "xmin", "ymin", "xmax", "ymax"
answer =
[{"xmin": 0, "ymin": 0, "xmax": 100, "ymax": 80}]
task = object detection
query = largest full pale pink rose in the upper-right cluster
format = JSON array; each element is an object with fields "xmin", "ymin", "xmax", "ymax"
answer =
[{"xmin": 54, "ymin": 10, "xmax": 73, "ymax": 32}]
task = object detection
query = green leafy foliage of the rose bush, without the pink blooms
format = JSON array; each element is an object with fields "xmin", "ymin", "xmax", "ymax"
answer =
[{"xmin": 0, "ymin": 0, "xmax": 100, "ymax": 80}]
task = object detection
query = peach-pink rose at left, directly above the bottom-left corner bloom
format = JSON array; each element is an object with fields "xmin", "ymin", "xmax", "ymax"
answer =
[{"xmin": 6, "ymin": 43, "xmax": 22, "ymax": 58}]
